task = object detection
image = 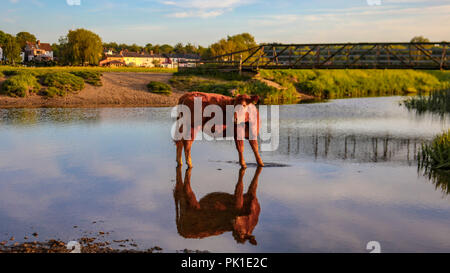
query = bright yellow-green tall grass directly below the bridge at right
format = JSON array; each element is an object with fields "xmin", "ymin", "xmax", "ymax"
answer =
[{"xmin": 260, "ymin": 69, "xmax": 450, "ymax": 99}]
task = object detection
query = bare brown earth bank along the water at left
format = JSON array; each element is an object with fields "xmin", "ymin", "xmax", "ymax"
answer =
[{"xmin": 0, "ymin": 72, "xmax": 184, "ymax": 108}]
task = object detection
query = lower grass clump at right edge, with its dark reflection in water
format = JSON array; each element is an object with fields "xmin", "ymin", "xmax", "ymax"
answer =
[{"xmin": 418, "ymin": 130, "xmax": 450, "ymax": 194}]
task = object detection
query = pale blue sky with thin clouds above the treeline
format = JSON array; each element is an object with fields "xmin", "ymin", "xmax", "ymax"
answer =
[{"xmin": 0, "ymin": 0, "xmax": 450, "ymax": 46}]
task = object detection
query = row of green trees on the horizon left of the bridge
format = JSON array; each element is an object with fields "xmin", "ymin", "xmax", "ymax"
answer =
[{"xmin": 0, "ymin": 29, "xmax": 257, "ymax": 65}]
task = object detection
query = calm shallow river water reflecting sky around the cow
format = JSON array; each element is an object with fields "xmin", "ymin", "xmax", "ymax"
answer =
[{"xmin": 0, "ymin": 97, "xmax": 450, "ymax": 252}]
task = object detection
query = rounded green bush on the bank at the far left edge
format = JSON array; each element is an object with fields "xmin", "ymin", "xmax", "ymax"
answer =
[{"xmin": 1, "ymin": 73, "xmax": 40, "ymax": 97}]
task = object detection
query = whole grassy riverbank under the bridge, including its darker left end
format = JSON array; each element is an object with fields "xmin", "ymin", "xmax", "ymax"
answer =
[{"xmin": 171, "ymin": 70, "xmax": 450, "ymax": 104}]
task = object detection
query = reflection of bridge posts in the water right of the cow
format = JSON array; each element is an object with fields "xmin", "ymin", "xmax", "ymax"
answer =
[{"xmin": 277, "ymin": 129, "xmax": 426, "ymax": 165}]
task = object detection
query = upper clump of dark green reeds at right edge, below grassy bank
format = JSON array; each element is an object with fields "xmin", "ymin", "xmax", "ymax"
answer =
[{"xmin": 404, "ymin": 89, "xmax": 450, "ymax": 115}]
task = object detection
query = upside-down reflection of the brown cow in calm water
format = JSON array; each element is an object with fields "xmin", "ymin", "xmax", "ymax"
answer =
[{"xmin": 174, "ymin": 167, "xmax": 262, "ymax": 245}]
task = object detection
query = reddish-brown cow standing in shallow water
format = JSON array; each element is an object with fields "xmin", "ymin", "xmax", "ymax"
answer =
[{"xmin": 175, "ymin": 92, "xmax": 264, "ymax": 168}]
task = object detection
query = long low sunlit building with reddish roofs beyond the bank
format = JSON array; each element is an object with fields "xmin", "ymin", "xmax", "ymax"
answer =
[{"xmin": 100, "ymin": 50, "xmax": 169, "ymax": 67}]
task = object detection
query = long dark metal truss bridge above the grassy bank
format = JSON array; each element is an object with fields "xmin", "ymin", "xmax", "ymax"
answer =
[{"xmin": 185, "ymin": 42, "xmax": 450, "ymax": 71}]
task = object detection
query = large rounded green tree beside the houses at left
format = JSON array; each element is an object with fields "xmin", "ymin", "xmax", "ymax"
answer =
[{"xmin": 67, "ymin": 28, "xmax": 103, "ymax": 65}]
